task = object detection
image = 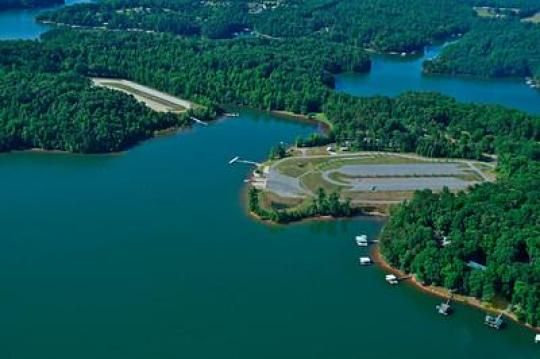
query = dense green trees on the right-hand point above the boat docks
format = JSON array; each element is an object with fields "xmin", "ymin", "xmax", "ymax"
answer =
[{"xmin": 381, "ymin": 156, "xmax": 540, "ymax": 326}]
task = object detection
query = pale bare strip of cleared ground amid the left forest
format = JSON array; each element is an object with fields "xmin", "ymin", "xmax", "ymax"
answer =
[{"xmin": 92, "ymin": 78, "xmax": 194, "ymax": 113}]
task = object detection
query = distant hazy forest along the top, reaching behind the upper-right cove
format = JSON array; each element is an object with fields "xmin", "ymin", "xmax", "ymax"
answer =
[{"xmin": 38, "ymin": 0, "xmax": 540, "ymax": 78}]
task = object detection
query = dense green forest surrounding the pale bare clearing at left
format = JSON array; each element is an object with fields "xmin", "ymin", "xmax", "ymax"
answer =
[{"xmin": 0, "ymin": 30, "xmax": 370, "ymax": 152}]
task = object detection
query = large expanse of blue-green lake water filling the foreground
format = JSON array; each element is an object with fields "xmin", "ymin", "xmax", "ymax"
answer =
[{"xmin": 0, "ymin": 5, "xmax": 540, "ymax": 359}]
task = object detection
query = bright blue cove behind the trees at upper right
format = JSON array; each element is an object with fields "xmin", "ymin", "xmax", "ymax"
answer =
[{"xmin": 336, "ymin": 46, "xmax": 540, "ymax": 114}]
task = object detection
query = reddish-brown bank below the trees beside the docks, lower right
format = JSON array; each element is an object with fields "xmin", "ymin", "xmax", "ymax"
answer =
[{"xmin": 371, "ymin": 244, "xmax": 540, "ymax": 333}]
